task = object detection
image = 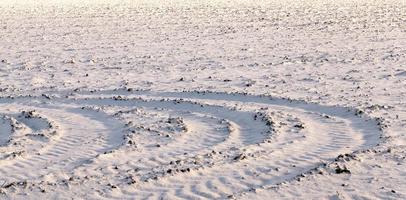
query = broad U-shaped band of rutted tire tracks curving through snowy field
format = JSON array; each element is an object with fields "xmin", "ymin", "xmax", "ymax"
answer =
[{"xmin": 0, "ymin": 91, "xmax": 380, "ymax": 199}]
